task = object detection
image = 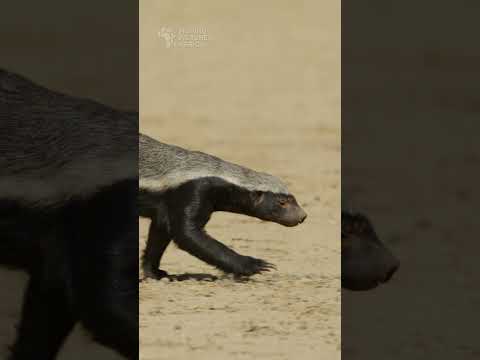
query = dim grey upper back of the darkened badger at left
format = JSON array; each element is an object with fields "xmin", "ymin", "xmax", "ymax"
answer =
[{"xmin": 0, "ymin": 69, "xmax": 138, "ymax": 207}]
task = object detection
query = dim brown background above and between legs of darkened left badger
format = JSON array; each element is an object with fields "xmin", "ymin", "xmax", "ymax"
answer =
[{"xmin": 0, "ymin": 0, "xmax": 138, "ymax": 360}]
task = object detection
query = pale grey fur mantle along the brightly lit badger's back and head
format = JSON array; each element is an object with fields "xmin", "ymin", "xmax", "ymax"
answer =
[{"xmin": 139, "ymin": 134, "xmax": 290, "ymax": 194}]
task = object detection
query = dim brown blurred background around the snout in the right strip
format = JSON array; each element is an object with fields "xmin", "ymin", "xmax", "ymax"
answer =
[{"xmin": 342, "ymin": 0, "xmax": 480, "ymax": 360}]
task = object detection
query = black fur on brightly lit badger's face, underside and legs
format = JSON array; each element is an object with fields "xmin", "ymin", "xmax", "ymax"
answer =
[{"xmin": 139, "ymin": 177, "xmax": 306, "ymax": 279}]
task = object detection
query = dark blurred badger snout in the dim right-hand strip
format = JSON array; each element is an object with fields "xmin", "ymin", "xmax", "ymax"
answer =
[{"xmin": 341, "ymin": 210, "xmax": 400, "ymax": 290}]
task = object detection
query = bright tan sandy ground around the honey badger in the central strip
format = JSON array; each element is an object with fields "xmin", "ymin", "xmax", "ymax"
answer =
[{"xmin": 140, "ymin": 0, "xmax": 340, "ymax": 360}]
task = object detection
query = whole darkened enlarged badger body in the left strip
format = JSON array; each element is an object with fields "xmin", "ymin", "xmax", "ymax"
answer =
[{"xmin": 0, "ymin": 69, "xmax": 138, "ymax": 359}]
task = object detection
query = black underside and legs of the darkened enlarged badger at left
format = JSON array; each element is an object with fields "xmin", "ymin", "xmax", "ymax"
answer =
[{"xmin": 0, "ymin": 181, "xmax": 138, "ymax": 360}]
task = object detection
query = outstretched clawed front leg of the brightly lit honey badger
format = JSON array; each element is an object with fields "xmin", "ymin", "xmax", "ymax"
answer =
[{"xmin": 169, "ymin": 181, "xmax": 274, "ymax": 276}]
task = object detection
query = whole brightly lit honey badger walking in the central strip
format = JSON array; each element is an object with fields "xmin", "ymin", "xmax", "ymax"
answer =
[{"xmin": 138, "ymin": 134, "xmax": 307, "ymax": 279}]
